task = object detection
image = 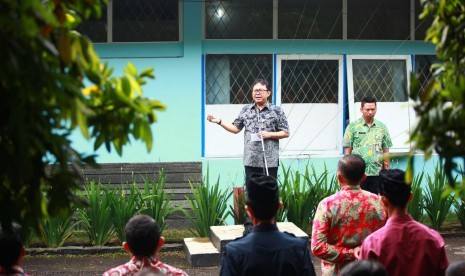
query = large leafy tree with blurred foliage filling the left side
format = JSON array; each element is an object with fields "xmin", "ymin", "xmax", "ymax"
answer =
[{"xmin": 0, "ymin": 0, "xmax": 165, "ymax": 229}]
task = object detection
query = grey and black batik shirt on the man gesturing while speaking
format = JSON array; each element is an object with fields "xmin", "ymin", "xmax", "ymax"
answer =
[{"xmin": 233, "ymin": 103, "xmax": 289, "ymax": 168}]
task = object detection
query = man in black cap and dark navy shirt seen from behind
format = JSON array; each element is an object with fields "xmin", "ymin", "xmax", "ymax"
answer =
[{"xmin": 220, "ymin": 174, "xmax": 315, "ymax": 275}]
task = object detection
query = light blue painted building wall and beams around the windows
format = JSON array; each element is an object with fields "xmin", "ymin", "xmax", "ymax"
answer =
[{"xmin": 73, "ymin": 1, "xmax": 435, "ymax": 187}]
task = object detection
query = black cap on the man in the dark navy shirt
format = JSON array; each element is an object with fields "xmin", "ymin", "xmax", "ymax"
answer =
[{"xmin": 246, "ymin": 173, "xmax": 279, "ymax": 205}]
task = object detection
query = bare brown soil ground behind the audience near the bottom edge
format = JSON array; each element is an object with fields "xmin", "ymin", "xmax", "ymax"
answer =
[{"xmin": 23, "ymin": 234, "xmax": 465, "ymax": 276}]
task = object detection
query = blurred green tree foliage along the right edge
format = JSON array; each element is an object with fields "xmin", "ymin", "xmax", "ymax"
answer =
[{"xmin": 410, "ymin": 0, "xmax": 465, "ymax": 198}]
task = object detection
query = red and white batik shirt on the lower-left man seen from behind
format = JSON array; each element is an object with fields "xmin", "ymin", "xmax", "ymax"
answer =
[{"xmin": 103, "ymin": 256, "xmax": 187, "ymax": 276}]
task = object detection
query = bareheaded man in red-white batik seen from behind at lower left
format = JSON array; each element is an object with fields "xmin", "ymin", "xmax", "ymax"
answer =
[{"xmin": 103, "ymin": 215, "xmax": 187, "ymax": 276}]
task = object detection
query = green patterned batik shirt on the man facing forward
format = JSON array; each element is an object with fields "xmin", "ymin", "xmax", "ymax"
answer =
[{"xmin": 342, "ymin": 118, "xmax": 392, "ymax": 176}]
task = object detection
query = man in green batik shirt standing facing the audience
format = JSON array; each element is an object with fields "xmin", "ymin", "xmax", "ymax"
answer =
[{"xmin": 342, "ymin": 97, "xmax": 392, "ymax": 194}]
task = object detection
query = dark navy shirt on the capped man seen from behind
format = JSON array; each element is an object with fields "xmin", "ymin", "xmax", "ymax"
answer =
[{"xmin": 220, "ymin": 224, "xmax": 316, "ymax": 276}]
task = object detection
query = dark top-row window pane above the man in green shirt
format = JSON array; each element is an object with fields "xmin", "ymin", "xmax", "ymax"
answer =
[{"xmin": 347, "ymin": 0, "xmax": 410, "ymax": 40}]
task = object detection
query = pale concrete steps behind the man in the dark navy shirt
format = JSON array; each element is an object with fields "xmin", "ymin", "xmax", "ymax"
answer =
[{"xmin": 184, "ymin": 222, "xmax": 308, "ymax": 267}]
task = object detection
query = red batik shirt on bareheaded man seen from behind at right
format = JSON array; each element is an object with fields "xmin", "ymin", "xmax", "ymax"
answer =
[{"xmin": 311, "ymin": 185, "xmax": 386, "ymax": 275}]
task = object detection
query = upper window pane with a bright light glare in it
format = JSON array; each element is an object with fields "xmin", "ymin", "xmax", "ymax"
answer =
[{"xmin": 205, "ymin": 0, "xmax": 273, "ymax": 39}]
